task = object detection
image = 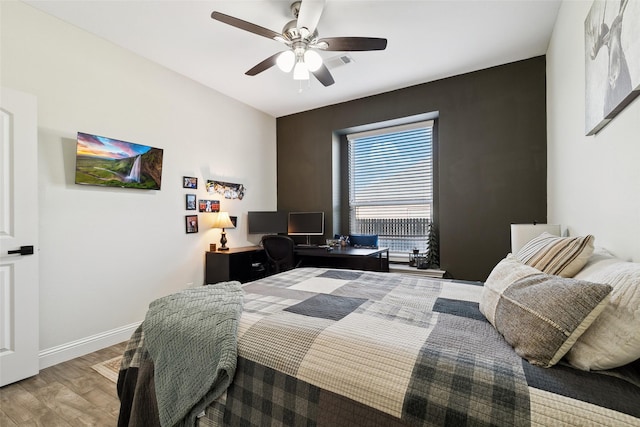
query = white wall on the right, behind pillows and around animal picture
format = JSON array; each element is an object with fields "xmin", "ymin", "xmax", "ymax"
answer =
[{"xmin": 547, "ymin": 1, "xmax": 640, "ymax": 261}]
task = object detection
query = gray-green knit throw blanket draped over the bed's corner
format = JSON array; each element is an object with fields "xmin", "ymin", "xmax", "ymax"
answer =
[{"xmin": 142, "ymin": 282, "xmax": 243, "ymax": 427}]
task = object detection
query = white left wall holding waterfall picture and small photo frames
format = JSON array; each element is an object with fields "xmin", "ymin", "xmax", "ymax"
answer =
[{"xmin": 0, "ymin": 1, "xmax": 277, "ymax": 367}]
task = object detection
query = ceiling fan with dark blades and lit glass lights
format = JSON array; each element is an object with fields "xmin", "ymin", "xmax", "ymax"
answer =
[{"xmin": 211, "ymin": 0, "xmax": 387, "ymax": 86}]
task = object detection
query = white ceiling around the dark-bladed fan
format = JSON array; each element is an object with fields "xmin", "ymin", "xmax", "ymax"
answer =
[{"xmin": 25, "ymin": 0, "xmax": 562, "ymax": 117}]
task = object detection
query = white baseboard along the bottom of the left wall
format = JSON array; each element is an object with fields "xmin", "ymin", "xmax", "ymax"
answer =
[{"xmin": 38, "ymin": 322, "xmax": 142, "ymax": 369}]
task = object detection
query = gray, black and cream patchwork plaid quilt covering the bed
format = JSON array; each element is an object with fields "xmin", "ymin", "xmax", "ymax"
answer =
[{"xmin": 118, "ymin": 242, "xmax": 640, "ymax": 426}]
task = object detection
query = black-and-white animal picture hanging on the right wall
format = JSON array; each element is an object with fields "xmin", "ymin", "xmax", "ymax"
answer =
[{"xmin": 584, "ymin": 0, "xmax": 640, "ymax": 135}]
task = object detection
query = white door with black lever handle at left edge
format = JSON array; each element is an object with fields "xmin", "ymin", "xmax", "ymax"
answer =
[{"xmin": 0, "ymin": 88, "xmax": 39, "ymax": 387}]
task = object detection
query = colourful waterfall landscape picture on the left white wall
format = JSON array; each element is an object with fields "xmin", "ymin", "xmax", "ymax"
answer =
[{"xmin": 76, "ymin": 132, "xmax": 163, "ymax": 190}]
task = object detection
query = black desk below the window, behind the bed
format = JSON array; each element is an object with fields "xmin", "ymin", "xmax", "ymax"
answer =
[{"xmin": 295, "ymin": 246, "xmax": 389, "ymax": 272}]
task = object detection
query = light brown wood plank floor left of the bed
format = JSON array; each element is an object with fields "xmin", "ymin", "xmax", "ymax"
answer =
[{"xmin": 0, "ymin": 343, "xmax": 126, "ymax": 427}]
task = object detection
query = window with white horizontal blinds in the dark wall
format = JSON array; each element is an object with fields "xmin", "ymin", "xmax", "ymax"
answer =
[{"xmin": 347, "ymin": 121, "xmax": 433, "ymax": 253}]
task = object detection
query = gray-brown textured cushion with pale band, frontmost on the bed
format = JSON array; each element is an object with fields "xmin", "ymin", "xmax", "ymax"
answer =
[{"xmin": 480, "ymin": 256, "xmax": 611, "ymax": 367}]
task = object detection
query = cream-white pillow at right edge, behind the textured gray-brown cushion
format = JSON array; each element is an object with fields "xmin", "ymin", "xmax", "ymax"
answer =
[{"xmin": 567, "ymin": 251, "xmax": 640, "ymax": 370}]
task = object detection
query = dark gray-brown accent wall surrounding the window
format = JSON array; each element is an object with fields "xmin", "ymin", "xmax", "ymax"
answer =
[{"xmin": 277, "ymin": 56, "xmax": 547, "ymax": 280}]
